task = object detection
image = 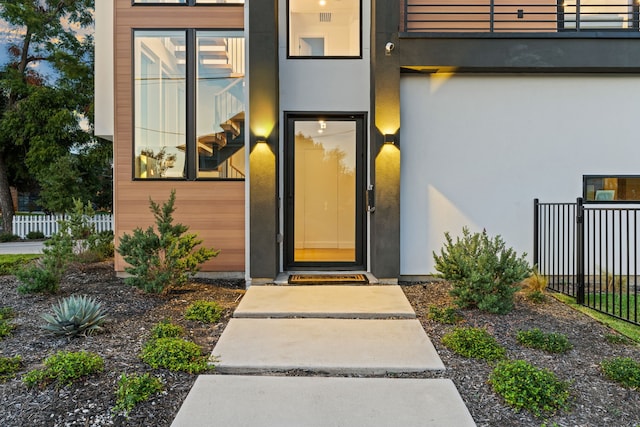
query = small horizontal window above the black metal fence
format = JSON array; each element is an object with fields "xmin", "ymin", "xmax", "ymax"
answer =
[{"xmin": 584, "ymin": 175, "xmax": 640, "ymax": 202}]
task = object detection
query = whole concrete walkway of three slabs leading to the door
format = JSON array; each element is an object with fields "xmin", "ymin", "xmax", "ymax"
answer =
[{"xmin": 172, "ymin": 286, "xmax": 475, "ymax": 427}]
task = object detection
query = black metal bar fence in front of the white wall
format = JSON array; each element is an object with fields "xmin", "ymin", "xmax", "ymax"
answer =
[{"xmin": 533, "ymin": 198, "xmax": 640, "ymax": 324}]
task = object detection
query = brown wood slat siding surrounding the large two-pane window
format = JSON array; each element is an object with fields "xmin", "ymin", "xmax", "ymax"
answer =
[{"xmin": 114, "ymin": 0, "xmax": 245, "ymax": 272}]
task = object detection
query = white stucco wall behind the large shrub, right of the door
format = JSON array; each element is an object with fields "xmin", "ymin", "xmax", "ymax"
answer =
[{"xmin": 400, "ymin": 75, "xmax": 640, "ymax": 275}]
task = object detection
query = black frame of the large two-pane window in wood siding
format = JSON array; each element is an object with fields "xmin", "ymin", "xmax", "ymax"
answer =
[{"xmin": 131, "ymin": 27, "xmax": 248, "ymax": 182}]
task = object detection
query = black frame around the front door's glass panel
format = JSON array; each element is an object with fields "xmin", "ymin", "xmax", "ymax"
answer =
[{"xmin": 283, "ymin": 112, "xmax": 368, "ymax": 271}]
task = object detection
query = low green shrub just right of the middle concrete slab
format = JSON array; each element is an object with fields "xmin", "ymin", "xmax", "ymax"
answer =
[{"xmin": 442, "ymin": 327, "xmax": 506, "ymax": 360}]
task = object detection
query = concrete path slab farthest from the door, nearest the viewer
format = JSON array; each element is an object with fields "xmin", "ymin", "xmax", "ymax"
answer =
[{"xmin": 172, "ymin": 375, "xmax": 475, "ymax": 427}]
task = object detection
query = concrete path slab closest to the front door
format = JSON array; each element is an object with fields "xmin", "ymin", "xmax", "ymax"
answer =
[{"xmin": 233, "ymin": 285, "xmax": 416, "ymax": 319}]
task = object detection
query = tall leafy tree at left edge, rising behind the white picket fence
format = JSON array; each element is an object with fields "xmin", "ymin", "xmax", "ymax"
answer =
[{"xmin": 0, "ymin": 0, "xmax": 96, "ymax": 231}]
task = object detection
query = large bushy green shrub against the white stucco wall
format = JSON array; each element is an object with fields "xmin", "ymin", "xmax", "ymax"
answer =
[{"xmin": 433, "ymin": 227, "xmax": 531, "ymax": 314}]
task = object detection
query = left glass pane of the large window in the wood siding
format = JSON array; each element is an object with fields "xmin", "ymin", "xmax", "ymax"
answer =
[{"xmin": 134, "ymin": 31, "xmax": 186, "ymax": 178}]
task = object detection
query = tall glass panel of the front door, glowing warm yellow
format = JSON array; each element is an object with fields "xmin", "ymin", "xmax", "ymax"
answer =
[{"xmin": 294, "ymin": 121, "xmax": 356, "ymax": 262}]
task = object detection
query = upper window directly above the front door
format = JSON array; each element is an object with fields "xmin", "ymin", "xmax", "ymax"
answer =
[{"xmin": 287, "ymin": 0, "xmax": 362, "ymax": 58}]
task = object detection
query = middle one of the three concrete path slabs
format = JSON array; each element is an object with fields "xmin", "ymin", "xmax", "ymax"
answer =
[{"xmin": 213, "ymin": 319, "xmax": 444, "ymax": 375}]
